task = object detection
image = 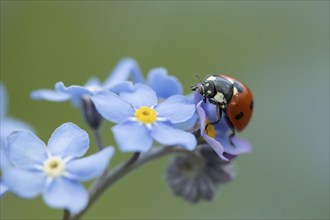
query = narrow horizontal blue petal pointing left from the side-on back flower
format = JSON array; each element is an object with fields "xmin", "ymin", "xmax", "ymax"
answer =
[{"xmin": 31, "ymin": 89, "xmax": 70, "ymax": 102}]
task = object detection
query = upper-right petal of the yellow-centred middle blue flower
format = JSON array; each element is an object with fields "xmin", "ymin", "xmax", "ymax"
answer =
[{"xmin": 155, "ymin": 95, "xmax": 195, "ymax": 123}]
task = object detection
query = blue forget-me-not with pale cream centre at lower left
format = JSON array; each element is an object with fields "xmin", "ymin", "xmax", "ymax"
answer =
[{"xmin": 4, "ymin": 123, "xmax": 114, "ymax": 213}]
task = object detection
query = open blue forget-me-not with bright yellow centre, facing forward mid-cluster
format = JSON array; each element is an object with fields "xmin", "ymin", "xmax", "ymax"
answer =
[{"xmin": 92, "ymin": 83, "xmax": 196, "ymax": 152}]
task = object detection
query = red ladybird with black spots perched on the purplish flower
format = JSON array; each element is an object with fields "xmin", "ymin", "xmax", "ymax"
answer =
[{"xmin": 191, "ymin": 74, "xmax": 253, "ymax": 145}]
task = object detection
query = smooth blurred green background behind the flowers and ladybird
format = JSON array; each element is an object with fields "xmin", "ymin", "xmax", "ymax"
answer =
[{"xmin": 1, "ymin": 1, "xmax": 329, "ymax": 219}]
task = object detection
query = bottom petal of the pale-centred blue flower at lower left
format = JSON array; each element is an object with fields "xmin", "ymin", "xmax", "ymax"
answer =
[{"xmin": 43, "ymin": 178, "xmax": 88, "ymax": 214}]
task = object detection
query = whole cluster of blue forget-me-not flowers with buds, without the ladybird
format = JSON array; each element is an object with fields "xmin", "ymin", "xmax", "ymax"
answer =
[{"xmin": 1, "ymin": 58, "xmax": 251, "ymax": 217}]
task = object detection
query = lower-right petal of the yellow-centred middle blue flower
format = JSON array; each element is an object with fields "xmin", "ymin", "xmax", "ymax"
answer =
[{"xmin": 151, "ymin": 123, "xmax": 197, "ymax": 150}]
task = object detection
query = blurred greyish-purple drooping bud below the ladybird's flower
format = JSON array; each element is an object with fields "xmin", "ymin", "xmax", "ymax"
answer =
[{"xmin": 166, "ymin": 144, "xmax": 234, "ymax": 203}]
